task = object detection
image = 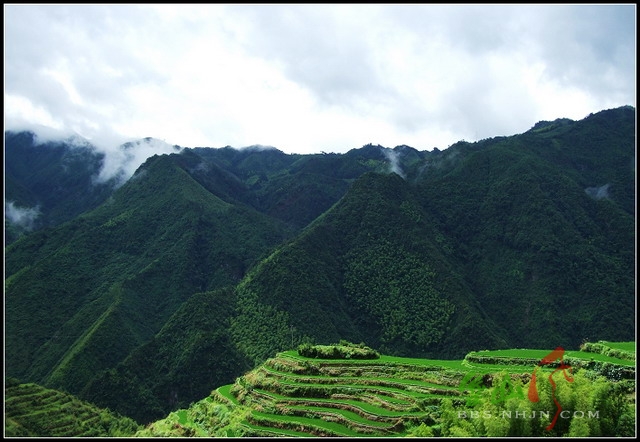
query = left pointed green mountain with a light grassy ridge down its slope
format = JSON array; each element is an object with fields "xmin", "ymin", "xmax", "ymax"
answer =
[{"xmin": 5, "ymin": 156, "xmax": 288, "ymax": 402}]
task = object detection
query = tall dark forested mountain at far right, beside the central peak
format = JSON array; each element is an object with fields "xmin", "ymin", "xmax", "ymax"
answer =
[{"xmin": 418, "ymin": 108, "xmax": 635, "ymax": 346}]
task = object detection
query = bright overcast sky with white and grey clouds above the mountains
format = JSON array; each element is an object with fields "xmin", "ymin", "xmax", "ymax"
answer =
[{"xmin": 4, "ymin": 4, "xmax": 636, "ymax": 153}]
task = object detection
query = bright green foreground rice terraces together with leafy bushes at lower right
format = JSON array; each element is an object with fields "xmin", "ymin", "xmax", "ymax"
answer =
[{"xmin": 136, "ymin": 341, "xmax": 636, "ymax": 437}]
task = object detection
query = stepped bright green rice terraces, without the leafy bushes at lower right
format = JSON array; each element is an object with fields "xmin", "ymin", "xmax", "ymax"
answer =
[{"xmin": 138, "ymin": 340, "xmax": 635, "ymax": 437}]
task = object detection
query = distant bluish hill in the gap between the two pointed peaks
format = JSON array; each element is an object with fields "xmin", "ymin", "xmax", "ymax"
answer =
[{"xmin": 187, "ymin": 146, "xmax": 390, "ymax": 229}]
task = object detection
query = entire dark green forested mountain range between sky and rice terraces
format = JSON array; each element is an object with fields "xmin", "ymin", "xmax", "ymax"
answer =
[{"xmin": 5, "ymin": 106, "xmax": 636, "ymax": 424}]
